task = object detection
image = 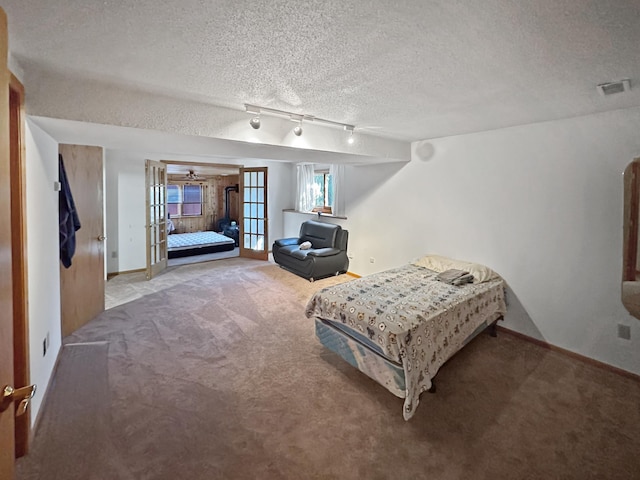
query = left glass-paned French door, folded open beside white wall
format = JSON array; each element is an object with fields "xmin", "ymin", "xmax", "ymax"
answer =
[{"xmin": 145, "ymin": 160, "xmax": 167, "ymax": 280}]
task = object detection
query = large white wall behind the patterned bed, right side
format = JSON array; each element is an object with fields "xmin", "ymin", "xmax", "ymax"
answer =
[{"xmin": 285, "ymin": 108, "xmax": 640, "ymax": 373}]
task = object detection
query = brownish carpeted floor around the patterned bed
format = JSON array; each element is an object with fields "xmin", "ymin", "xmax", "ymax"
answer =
[{"xmin": 17, "ymin": 259, "xmax": 640, "ymax": 480}]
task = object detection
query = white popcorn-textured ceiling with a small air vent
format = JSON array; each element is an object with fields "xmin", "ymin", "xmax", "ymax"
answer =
[{"xmin": 3, "ymin": 0, "xmax": 640, "ymax": 141}]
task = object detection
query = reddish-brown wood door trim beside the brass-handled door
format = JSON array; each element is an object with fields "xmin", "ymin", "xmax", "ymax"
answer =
[{"xmin": 9, "ymin": 74, "xmax": 31, "ymax": 457}]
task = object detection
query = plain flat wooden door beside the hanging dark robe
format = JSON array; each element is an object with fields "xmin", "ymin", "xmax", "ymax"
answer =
[{"xmin": 59, "ymin": 145, "xmax": 106, "ymax": 337}]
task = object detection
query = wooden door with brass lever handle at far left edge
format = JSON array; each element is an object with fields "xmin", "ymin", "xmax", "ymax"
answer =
[{"xmin": 0, "ymin": 8, "xmax": 15, "ymax": 479}]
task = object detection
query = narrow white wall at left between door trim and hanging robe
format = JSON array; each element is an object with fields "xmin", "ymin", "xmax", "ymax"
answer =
[{"xmin": 25, "ymin": 120, "xmax": 62, "ymax": 423}]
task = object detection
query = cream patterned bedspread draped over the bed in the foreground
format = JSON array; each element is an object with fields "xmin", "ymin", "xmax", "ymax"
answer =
[{"xmin": 306, "ymin": 264, "xmax": 507, "ymax": 420}]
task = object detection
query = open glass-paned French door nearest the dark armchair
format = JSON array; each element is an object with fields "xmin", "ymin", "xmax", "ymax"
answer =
[{"xmin": 240, "ymin": 167, "xmax": 269, "ymax": 260}]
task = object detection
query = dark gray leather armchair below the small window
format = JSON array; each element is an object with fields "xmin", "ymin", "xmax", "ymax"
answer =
[{"xmin": 272, "ymin": 220, "xmax": 349, "ymax": 282}]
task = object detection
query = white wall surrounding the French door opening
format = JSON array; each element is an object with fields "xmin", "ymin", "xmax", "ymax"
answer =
[{"xmin": 105, "ymin": 150, "xmax": 293, "ymax": 273}]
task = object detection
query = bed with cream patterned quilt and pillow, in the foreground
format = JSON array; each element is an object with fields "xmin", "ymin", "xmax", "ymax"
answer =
[{"xmin": 305, "ymin": 255, "xmax": 506, "ymax": 420}]
